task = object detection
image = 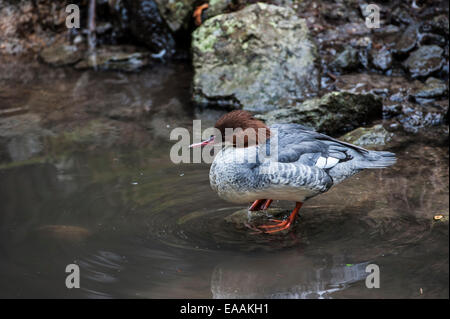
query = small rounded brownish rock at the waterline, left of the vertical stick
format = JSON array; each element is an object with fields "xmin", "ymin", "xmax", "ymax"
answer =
[{"xmin": 39, "ymin": 43, "xmax": 83, "ymax": 66}]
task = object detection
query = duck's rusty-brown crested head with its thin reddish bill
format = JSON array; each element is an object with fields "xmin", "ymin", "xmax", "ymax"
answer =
[{"xmin": 191, "ymin": 110, "xmax": 270, "ymax": 147}]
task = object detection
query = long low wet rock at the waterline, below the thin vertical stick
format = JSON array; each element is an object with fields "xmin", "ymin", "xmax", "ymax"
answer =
[{"xmin": 75, "ymin": 45, "xmax": 149, "ymax": 71}]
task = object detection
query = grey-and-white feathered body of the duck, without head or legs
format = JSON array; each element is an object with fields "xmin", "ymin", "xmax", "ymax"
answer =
[{"xmin": 210, "ymin": 124, "xmax": 396, "ymax": 203}]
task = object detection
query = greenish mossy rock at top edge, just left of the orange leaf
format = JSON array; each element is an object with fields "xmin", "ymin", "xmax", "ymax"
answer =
[{"xmin": 155, "ymin": 0, "xmax": 196, "ymax": 32}]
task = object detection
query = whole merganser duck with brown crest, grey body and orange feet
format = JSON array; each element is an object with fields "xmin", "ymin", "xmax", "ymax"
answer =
[{"xmin": 191, "ymin": 110, "xmax": 396, "ymax": 233}]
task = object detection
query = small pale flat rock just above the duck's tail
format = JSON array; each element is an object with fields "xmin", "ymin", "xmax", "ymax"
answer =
[{"xmin": 339, "ymin": 124, "xmax": 394, "ymax": 148}]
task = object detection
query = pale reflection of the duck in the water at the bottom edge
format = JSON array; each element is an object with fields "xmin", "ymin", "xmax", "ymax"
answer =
[{"xmin": 211, "ymin": 254, "xmax": 368, "ymax": 299}]
